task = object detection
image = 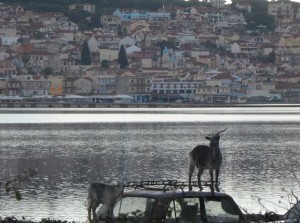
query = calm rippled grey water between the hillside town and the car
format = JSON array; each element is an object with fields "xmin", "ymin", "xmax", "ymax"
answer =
[{"xmin": 0, "ymin": 107, "xmax": 300, "ymax": 222}]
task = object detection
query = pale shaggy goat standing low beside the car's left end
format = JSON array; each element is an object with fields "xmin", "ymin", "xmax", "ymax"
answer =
[{"xmin": 87, "ymin": 183, "xmax": 124, "ymax": 223}]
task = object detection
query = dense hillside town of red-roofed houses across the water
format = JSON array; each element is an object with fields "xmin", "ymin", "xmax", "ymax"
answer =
[{"xmin": 0, "ymin": 0, "xmax": 300, "ymax": 104}]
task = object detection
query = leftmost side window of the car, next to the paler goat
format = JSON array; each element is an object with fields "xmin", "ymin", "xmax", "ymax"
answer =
[{"xmin": 113, "ymin": 197, "xmax": 155, "ymax": 222}]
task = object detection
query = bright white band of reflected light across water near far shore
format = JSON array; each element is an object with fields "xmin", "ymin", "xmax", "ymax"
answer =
[{"xmin": 0, "ymin": 113, "xmax": 300, "ymax": 124}]
